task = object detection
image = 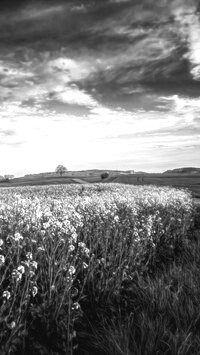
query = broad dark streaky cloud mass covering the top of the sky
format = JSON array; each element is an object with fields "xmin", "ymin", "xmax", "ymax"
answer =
[{"xmin": 0, "ymin": 0, "xmax": 198, "ymax": 112}]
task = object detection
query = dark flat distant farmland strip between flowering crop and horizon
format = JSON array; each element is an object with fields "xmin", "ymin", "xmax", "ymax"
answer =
[{"xmin": 0, "ymin": 171, "xmax": 200, "ymax": 198}]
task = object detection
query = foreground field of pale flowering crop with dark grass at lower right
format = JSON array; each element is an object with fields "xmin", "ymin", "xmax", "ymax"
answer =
[{"xmin": 0, "ymin": 183, "xmax": 200, "ymax": 355}]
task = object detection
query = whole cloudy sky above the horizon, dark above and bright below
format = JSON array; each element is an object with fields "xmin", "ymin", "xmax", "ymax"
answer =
[{"xmin": 0, "ymin": 0, "xmax": 200, "ymax": 176}]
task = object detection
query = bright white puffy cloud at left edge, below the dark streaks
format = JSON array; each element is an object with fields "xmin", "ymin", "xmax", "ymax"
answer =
[{"xmin": 0, "ymin": 51, "xmax": 98, "ymax": 111}]
